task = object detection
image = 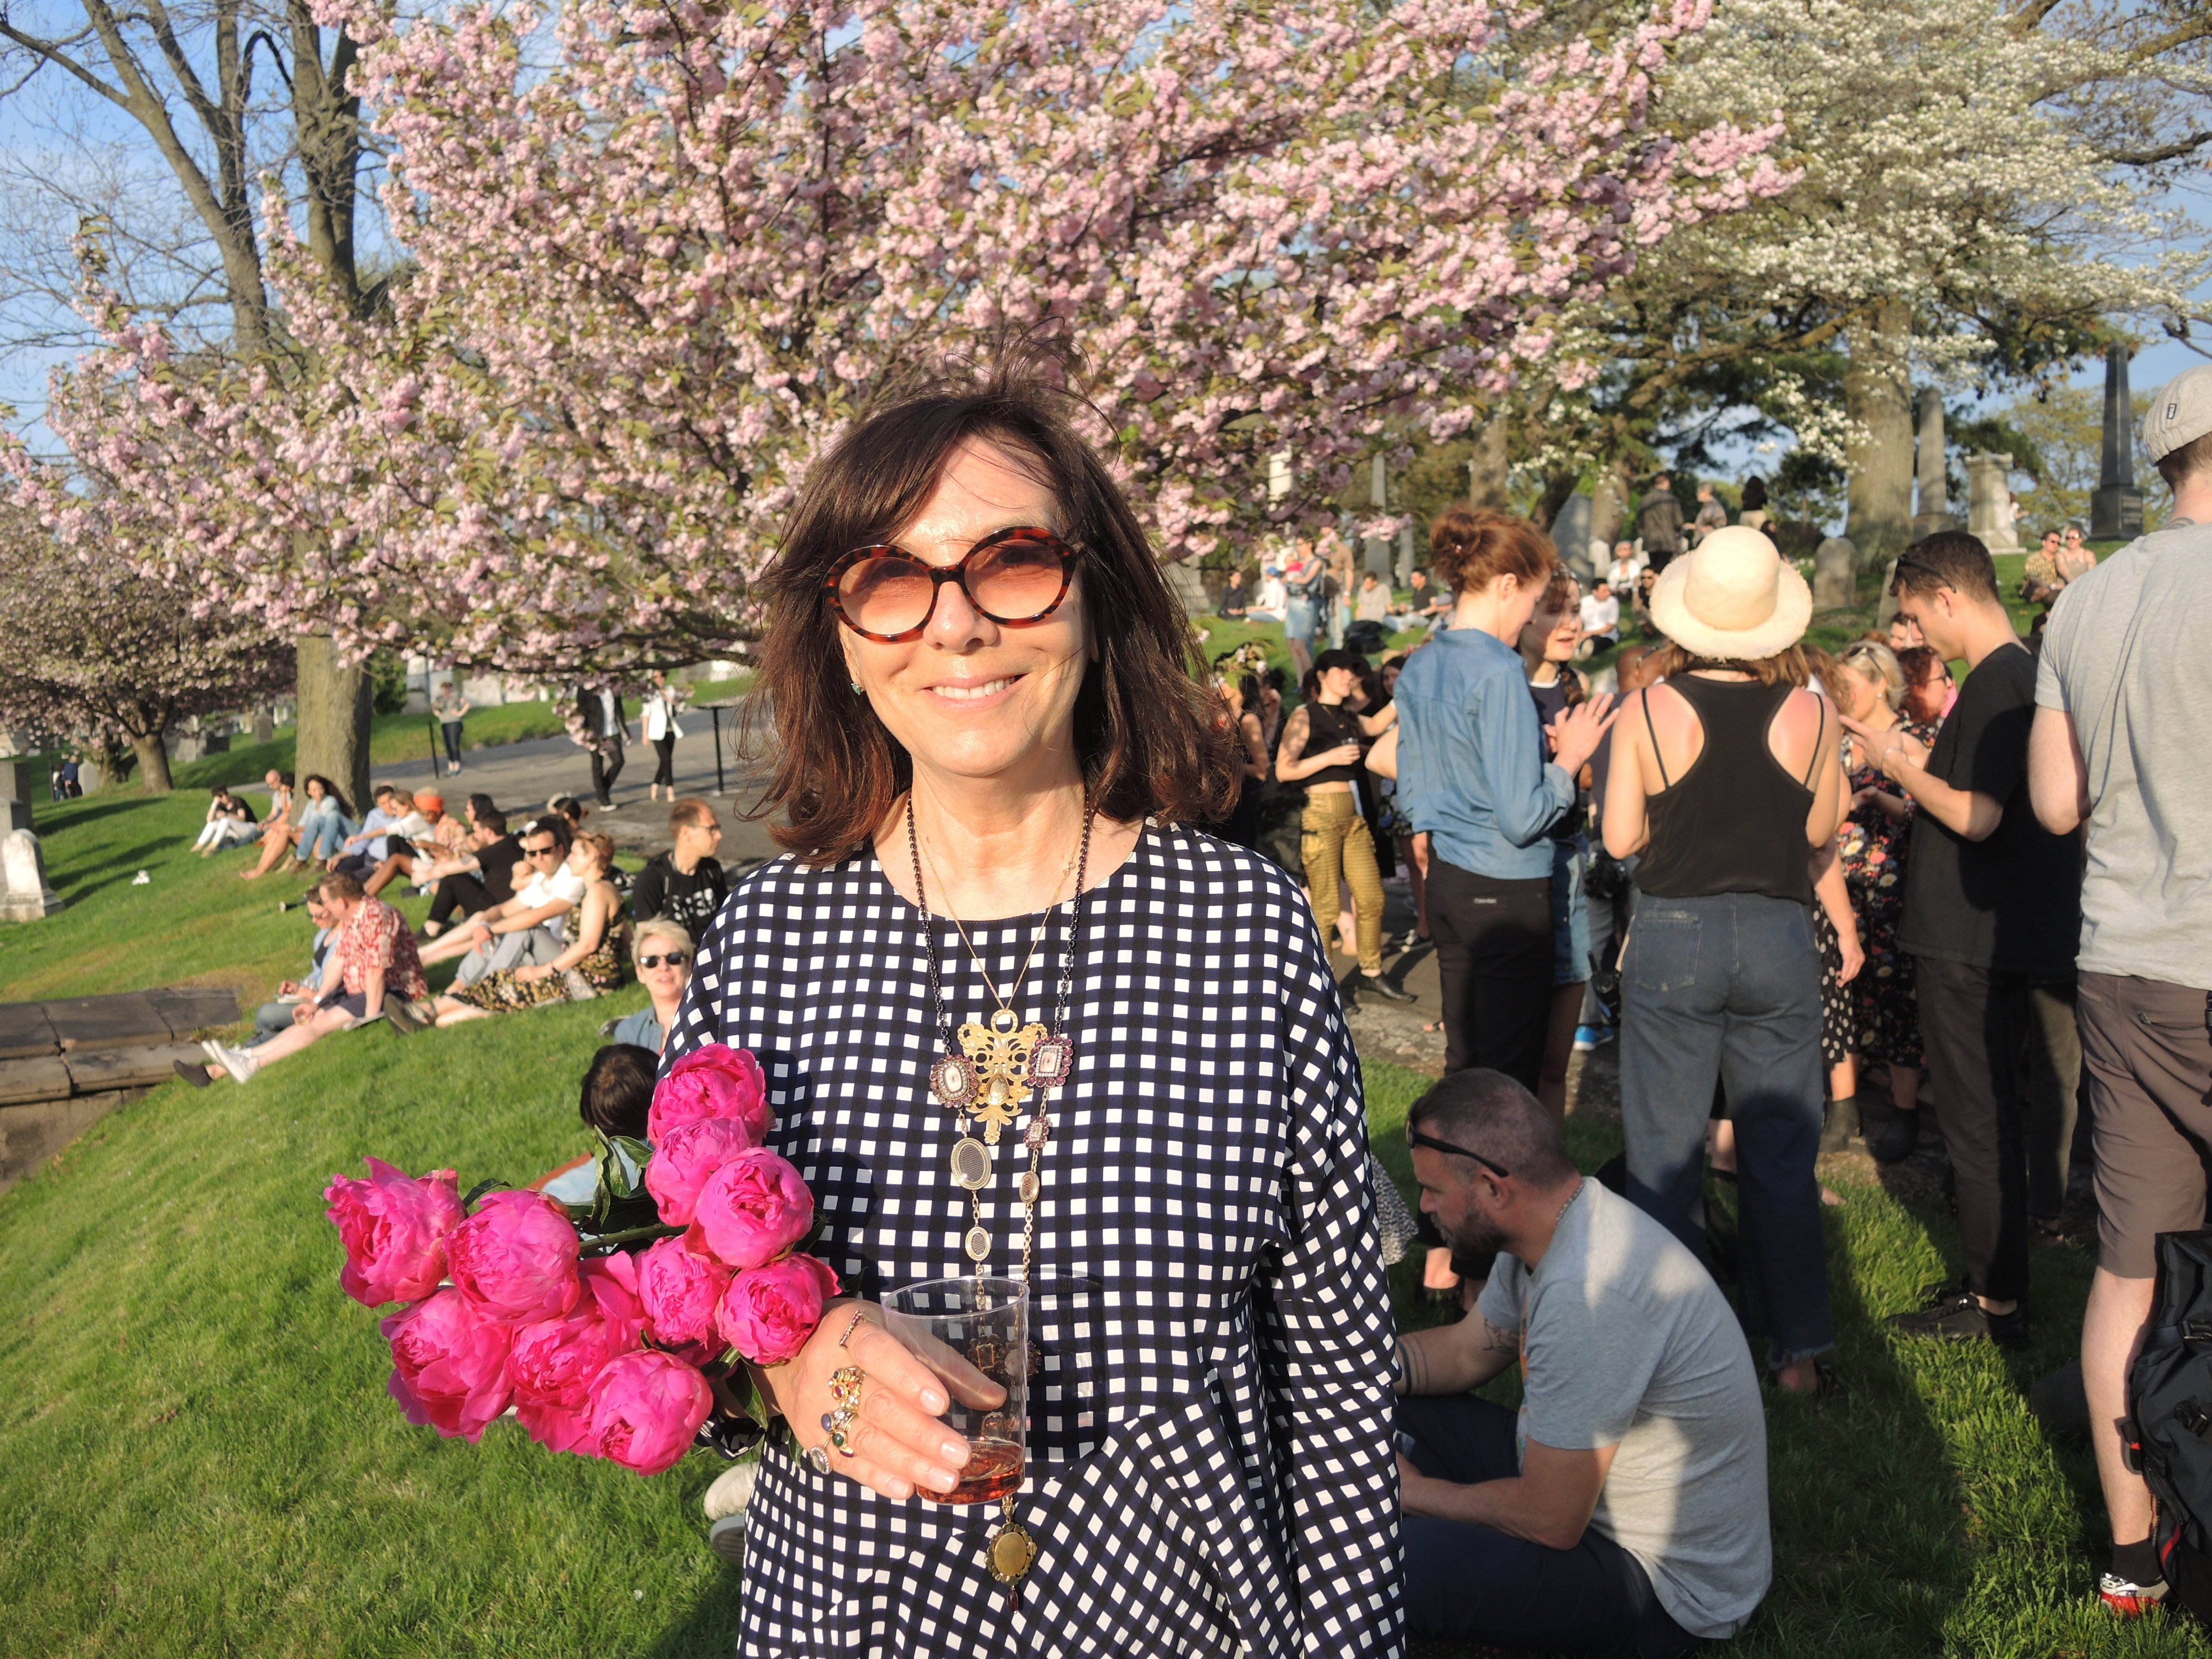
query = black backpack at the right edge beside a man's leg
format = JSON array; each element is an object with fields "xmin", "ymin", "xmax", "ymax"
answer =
[{"xmin": 2128, "ymin": 1228, "xmax": 2212, "ymax": 1624}]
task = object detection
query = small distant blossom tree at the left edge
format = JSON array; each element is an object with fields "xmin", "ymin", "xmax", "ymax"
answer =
[{"xmin": 0, "ymin": 507, "xmax": 294, "ymax": 794}]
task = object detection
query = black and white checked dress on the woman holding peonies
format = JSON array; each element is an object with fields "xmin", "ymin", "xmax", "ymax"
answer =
[{"xmin": 666, "ymin": 827, "xmax": 1402, "ymax": 1659}]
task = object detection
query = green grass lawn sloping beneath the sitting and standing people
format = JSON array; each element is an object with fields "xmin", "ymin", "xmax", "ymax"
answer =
[{"xmin": 0, "ymin": 799, "xmax": 2212, "ymax": 1659}]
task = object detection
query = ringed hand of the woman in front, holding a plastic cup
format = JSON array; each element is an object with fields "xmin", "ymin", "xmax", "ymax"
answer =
[{"xmin": 763, "ymin": 1298, "xmax": 1004, "ymax": 1500}]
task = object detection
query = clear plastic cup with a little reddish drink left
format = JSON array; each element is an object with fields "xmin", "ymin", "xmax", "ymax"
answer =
[{"xmin": 883, "ymin": 1279, "xmax": 1029, "ymax": 1504}]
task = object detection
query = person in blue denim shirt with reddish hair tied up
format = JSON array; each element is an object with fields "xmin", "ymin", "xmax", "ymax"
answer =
[{"xmin": 1396, "ymin": 507, "xmax": 1613, "ymax": 1091}]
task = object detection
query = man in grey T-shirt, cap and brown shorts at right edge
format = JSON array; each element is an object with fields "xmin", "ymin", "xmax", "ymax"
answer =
[{"xmin": 2028, "ymin": 367, "xmax": 2212, "ymax": 1617}]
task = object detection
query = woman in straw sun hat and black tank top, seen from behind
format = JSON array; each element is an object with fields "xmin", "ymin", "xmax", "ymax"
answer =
[{"xmin": 1604, "ymin": 524, "xmax": 1847, "ymax": 1394}]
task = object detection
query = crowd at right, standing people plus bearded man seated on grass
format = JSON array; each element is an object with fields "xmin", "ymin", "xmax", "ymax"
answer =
[{"xmin": 1168, "ymin": 372, "xmax": 2212, "ymax": 1652}]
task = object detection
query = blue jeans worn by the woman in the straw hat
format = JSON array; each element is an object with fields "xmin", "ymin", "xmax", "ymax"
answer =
[{"xmin": 1621, "ymin": 894, "xmax": 1836, "ymax": 1367}]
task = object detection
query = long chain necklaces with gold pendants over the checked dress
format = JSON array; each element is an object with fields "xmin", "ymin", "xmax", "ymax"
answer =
[{"xmin": 907, "ymin": 794, "xmax": 1097, "ymax": 1601}]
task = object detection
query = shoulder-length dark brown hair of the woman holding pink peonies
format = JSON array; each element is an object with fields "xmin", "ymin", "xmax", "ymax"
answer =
[{"xmin": 745, "ymin": 352, "xmax": 1239, "ymax": 865}]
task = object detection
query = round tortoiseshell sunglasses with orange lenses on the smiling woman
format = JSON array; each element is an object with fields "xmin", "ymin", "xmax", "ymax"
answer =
[{"xmin": 823, "ymin": 524, "xmax": 1075, "ymax": 646}]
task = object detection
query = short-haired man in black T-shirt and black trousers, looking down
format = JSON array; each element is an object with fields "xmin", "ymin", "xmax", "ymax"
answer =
[{"xmin": 1845, "ymin": 531, "xmax": 2081, "ymax": 1347}]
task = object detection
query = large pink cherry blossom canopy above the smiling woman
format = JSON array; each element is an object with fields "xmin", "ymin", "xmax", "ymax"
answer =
[{"xmin": 29, "ymin": 0, "xmax": 1787, "ymax": 672}]
